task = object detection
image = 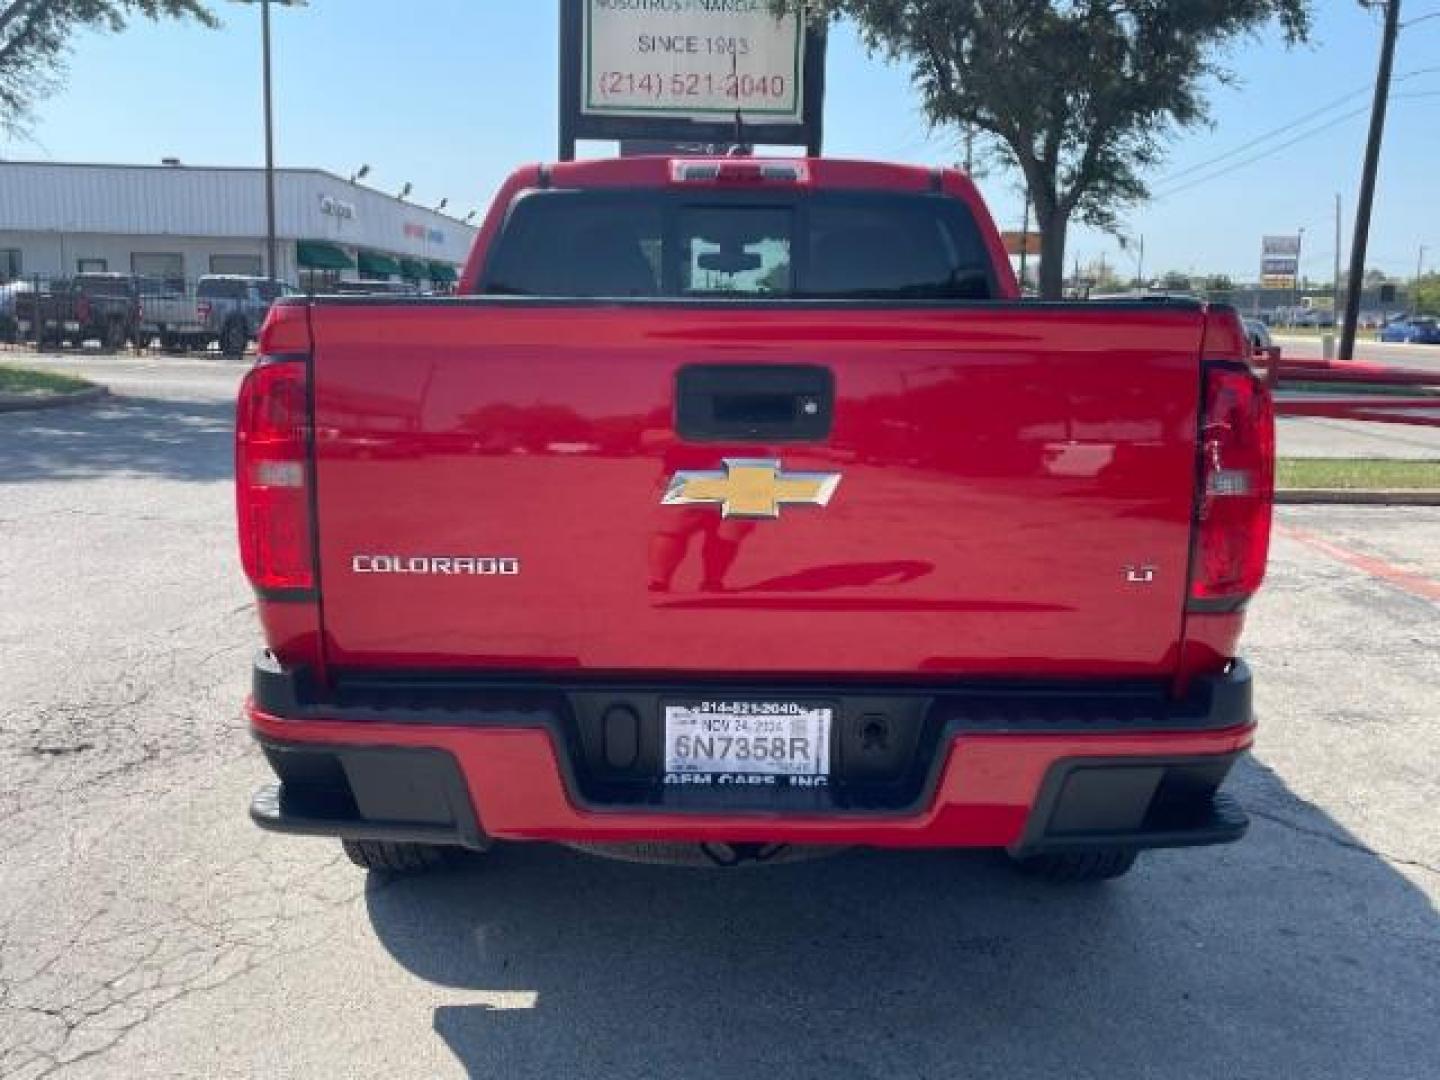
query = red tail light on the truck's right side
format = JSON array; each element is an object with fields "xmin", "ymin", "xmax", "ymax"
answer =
[{"xmin": 1189, "ymin": 363, "xmax": 1274, "ymax": 611}]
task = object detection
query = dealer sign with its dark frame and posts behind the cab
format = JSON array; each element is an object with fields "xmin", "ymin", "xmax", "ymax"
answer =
[{"xmin": 560, "ymin": 0, "xmax": 825, "ymax": 161}]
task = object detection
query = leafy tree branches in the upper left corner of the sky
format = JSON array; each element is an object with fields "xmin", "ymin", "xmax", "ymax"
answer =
[{"xmin": 0, "ymin": 0, "xmax": 220, "ymax": 132}]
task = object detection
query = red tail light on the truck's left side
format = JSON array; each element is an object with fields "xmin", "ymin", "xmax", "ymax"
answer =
[{"xmin": 235, "ymin": 356, "xmax": 315, "ymax": 599}]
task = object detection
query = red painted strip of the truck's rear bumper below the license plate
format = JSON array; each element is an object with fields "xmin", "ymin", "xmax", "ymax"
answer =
[{"xmin": 249, "ymin": 706, "xmax": 1254, "ymax": 847}]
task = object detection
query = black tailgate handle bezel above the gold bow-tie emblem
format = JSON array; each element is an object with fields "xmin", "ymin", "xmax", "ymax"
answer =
[{"xmin": 675, "ymin": 364, "xmax": 835, "ymax": 442}]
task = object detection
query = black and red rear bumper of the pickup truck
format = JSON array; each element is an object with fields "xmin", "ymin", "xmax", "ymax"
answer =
[{"xmin": 248, "ymin": 658, "xmax": 1254, "ymax": 854}]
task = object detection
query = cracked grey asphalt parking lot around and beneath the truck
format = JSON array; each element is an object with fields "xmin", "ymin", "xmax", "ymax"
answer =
[{"xmin": 0, "ymin": 359, "xmax": 1440, "ymax": 1080}]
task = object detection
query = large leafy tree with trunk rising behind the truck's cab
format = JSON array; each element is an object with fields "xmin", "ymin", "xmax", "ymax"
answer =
[{"xmin": 772, "ymin": 0, "xmax": 1312, "ymax": 298}]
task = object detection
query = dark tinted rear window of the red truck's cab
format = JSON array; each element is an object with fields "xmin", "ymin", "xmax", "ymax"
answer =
[{"xmin": 481, "ymin": 190, "xmax": 995, "ymax": 301}]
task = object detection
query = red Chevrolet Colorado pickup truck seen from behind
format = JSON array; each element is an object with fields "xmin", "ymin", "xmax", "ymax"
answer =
[{"xmin": 236, "ymin": 158, "xmax": 1274, "ymax": 880}]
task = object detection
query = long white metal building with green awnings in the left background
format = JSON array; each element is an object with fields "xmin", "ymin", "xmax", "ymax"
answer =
[{"xmin": 0, "ymin": 161, "xmax": 475, "ymax": 288}]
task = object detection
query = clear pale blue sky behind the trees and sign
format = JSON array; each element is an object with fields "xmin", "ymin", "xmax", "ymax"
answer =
[{"xmin": 0, "ymin": 0, "xmax": 1440, "ymax": 279}]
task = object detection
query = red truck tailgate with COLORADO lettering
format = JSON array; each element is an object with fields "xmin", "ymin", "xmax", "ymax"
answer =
[{"xmin": 311, "ymin": 300, "xmax": 1204, "ymax": 677}]
